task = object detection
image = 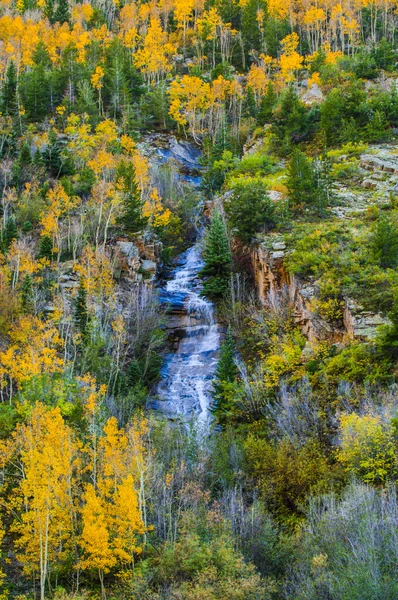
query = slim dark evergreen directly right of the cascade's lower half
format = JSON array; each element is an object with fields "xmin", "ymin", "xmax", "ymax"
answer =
[{"xmin": 211, "ymin": 326, "xmax": 238, "ymax": 423}]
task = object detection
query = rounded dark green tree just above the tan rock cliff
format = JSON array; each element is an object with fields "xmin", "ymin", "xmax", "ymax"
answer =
[{"xmin": 225, "ymin": 181, "xmax": 275, "ymax": 243}]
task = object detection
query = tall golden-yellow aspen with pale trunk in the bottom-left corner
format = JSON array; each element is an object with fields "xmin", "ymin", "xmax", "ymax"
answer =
[{"xmin": 12, "ymin": 403, "xmax": 79, "ymax": 599}]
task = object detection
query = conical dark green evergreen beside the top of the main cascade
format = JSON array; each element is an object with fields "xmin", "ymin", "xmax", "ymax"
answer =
[{"xmin": 201, "ymin": 209, "xmax": 232, "ymax": 298}]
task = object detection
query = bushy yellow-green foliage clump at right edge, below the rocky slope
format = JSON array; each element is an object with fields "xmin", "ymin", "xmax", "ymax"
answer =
[{"xmin": 337, "ymin": 413, "xmax": 397, "ymax": 484}]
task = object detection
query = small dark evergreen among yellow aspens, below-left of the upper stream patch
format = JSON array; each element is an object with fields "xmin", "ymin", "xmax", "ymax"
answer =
[{"xmin": 117, "ymin": 161, "xmax": 148, "ymax": 235}]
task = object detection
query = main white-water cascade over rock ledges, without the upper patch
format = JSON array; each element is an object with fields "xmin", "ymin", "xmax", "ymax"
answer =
[{"xmin": 150, "ymin": 243, "xmax": 220, "ymax": 429}]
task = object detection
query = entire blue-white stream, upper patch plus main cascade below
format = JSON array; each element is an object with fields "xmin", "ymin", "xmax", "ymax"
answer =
[{"xmin": 148, "ymin": 140, "xmax": 220, "ymax": 432}]
